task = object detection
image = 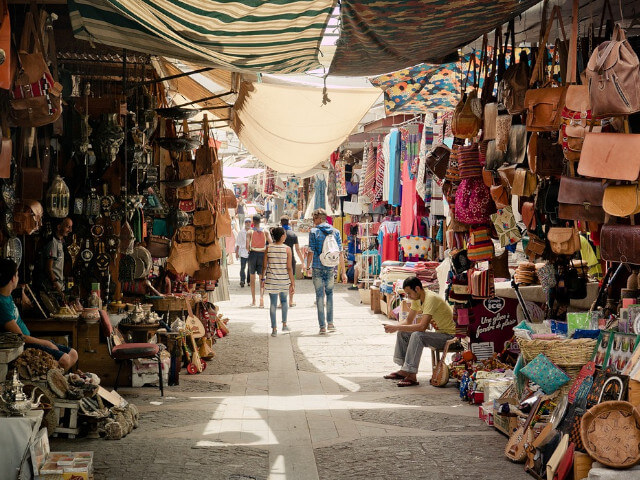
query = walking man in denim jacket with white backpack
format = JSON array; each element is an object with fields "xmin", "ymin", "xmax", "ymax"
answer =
[{"xmin": 307, "ymin": 208, "xmax": 347, "ymax": 335}]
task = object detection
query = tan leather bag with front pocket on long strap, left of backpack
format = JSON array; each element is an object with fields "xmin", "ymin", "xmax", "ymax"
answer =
[{"xmin": 524, "ymin": 6, "xmax": 567, "ymax": 132}]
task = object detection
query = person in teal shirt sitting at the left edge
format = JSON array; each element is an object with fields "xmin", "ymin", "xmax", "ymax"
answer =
[{"xmin": 0, "ymin": 258, "xmax": 78, "ymax": 370}]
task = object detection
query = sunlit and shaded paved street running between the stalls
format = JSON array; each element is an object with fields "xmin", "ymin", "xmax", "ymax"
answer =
[{"xmin": 51, "ymin": 263, "xmax": 528, "ymax": 480}]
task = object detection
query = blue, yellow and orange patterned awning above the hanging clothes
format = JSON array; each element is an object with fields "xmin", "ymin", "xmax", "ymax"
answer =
[{"xmin": 369, "ymin": 62, "xmax": 462, "ymax": 115}]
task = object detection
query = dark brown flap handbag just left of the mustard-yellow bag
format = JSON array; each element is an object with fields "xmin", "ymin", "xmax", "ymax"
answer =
[{"xmin": 558, "ymin": 177, "xmax": 605, "ymax": 223}]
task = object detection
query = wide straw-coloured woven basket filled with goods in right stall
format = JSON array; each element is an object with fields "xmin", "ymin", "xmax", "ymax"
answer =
[{"xmin": 518, "ymin": 338, "xmax": 596, "ymax": 370}]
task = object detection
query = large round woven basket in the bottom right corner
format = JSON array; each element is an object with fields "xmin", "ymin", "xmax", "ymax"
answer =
[{"xmin": 580, "ymin": 402, "xmax": 640, "ymax": 468}]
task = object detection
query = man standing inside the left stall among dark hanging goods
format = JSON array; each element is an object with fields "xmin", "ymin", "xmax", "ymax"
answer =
[{"xmin": 34, "ymin": 218, "xmax": 73, "ymax": 297}]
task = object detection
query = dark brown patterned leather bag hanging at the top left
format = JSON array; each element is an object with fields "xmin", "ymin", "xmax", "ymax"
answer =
[{"xmin": 10, "ymin": 7, "xmax": 62, "ymax": 127}]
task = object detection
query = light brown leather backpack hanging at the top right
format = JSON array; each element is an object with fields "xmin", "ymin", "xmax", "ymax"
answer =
[{"xmin": 586, "ymin": 24, "xmax": 640, "ymax": 115}]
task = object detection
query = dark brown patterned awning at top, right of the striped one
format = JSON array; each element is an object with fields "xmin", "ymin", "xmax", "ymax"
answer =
[{"xmin": 329, "ymin": 0, "xmax": 539, "ymax": 76}]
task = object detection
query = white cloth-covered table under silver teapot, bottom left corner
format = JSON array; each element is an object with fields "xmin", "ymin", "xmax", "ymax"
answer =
[{"xmin": 0, "ymin": 410, "xmax": 44, "ymax": 480}]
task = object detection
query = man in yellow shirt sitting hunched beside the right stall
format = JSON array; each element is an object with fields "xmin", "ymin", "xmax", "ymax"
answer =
[{"xmin": 384, "ymin": 277, "xmax": 456, "ymax": 387}]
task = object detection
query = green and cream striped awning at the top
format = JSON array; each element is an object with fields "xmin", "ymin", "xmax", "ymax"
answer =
[{"xmin": 68, "ymin": 0, "xmax": 335, "ymax": 73}]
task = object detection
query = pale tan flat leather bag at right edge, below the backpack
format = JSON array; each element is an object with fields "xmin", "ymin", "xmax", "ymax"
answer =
[{"xmin": 578, "ymin": 132, "xmax": 640, "ymax": 182}]
